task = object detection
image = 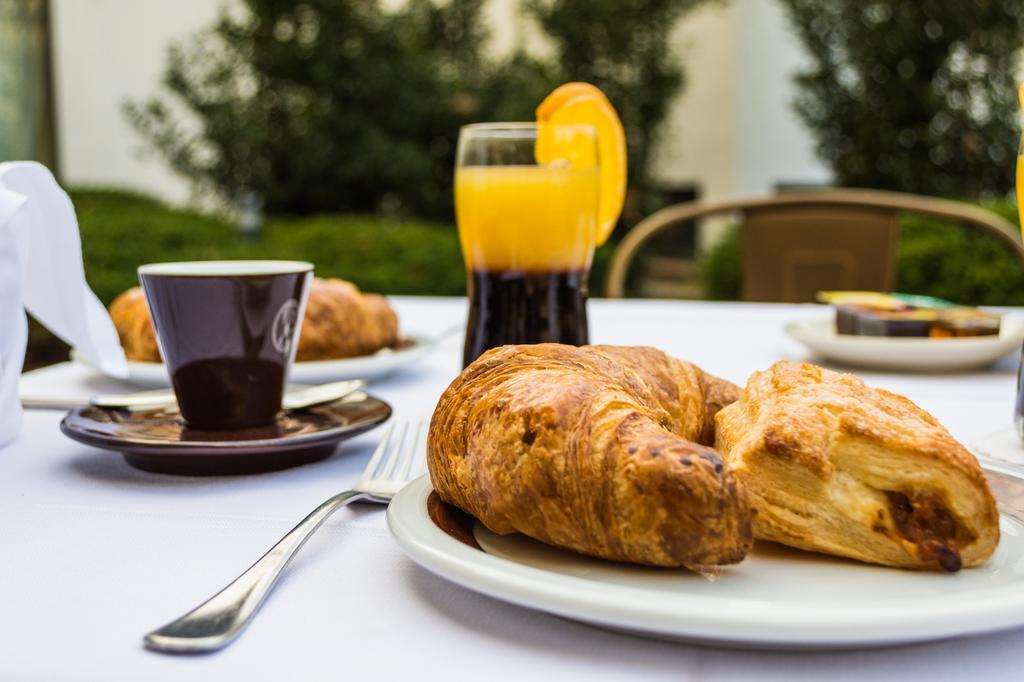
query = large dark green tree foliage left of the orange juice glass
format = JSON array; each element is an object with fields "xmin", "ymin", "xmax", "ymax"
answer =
[{"xmin": 128, "ymin": 0, "xmax": 524, "ymax": 215}]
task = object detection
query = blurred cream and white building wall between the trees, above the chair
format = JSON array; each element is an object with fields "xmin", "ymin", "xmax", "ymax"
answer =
[{"xmin": 654, "ymin": 0, "xmax": 829, "ymax": 199}]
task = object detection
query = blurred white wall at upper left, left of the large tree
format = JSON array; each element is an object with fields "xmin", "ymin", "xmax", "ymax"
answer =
[{"xmin": 51, "ymin": 0, "xmax": 232, "ymax": 203}]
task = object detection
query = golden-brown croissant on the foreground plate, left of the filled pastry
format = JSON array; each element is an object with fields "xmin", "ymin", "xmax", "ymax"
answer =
[{"xmin": 427, "ymin": 343, "xmax": 753, "ymax": 566}]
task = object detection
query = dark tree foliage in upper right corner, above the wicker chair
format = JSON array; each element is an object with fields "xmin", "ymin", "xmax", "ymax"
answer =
[{"xmin": 781, "ymin": 0, "xmax": 1024, "ymax": 198}]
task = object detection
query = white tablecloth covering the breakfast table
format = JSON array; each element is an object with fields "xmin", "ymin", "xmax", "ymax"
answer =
[{"xmin": 0, "ymin": 298, "xmax": 1024, "ymax": 682}]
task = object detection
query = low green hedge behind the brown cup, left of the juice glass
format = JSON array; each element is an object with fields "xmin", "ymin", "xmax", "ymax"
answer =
[{"xmin": 71, "ymin": 189, "xmax": 465, "ymax": 303}]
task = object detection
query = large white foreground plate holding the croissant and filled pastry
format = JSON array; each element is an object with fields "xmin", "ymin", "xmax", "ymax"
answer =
[{"xmin": 387, "ymin": 464, "xmax": 1024, "ymax": 648}]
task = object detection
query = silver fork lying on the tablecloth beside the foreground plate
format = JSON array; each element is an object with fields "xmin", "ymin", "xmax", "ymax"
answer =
[{"xmin": 143, "ymin": 421, "xmax": 423, "ymax": 653}]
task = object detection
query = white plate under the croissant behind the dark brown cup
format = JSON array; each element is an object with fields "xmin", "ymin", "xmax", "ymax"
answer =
[{"xmin": 71, "ymin": 335, "xmax": 437, "ymax": 386}]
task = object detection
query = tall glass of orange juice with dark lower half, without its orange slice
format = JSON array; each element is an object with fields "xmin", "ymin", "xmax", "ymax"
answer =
[{"xmin": 455, "ymin": 123, "xmax": 600, "ymax": 366}]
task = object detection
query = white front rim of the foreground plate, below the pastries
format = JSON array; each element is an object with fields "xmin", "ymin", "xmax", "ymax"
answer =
[{"xmin": 387, "ymin": 472, "xmax": 1024, "ymax": 648}]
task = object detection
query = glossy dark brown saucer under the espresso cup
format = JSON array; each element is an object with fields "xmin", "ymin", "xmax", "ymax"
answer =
[{"xmin": 60, "ymin": 392, "xmax": 391, "ymax": 476}]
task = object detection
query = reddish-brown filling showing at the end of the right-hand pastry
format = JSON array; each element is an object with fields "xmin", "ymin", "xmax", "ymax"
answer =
[{"xmin": 885, "ymin": 491, "xmax": 976, "ymax": 572}]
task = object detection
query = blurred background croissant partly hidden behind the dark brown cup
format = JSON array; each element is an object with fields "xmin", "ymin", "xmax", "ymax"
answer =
[{"xmin": 110, "ymin": 278, "xmax": 398, "ymax": 363}]
